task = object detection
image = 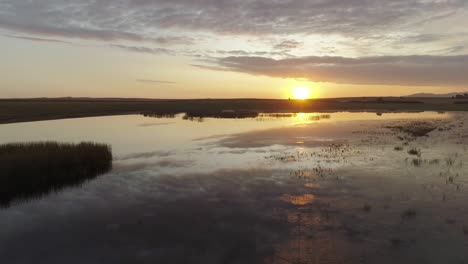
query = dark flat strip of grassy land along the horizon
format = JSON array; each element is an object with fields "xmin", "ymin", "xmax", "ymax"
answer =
[{"xmin": 0, "ymin": 97, "xmax": 468, "ymax": 124}]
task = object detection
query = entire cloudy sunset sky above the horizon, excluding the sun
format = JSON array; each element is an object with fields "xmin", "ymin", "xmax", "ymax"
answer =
[{"xmin": 0, "ymin": 0, "xmax": 468, "ymax": 98}]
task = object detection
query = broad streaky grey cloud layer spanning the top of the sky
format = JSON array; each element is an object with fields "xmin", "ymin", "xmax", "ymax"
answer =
[{"xmin": 0, "ymin": 0, "xmax": 468, "ymax": 58}]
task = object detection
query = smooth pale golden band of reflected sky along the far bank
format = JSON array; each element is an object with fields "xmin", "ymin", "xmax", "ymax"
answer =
[{"xmin": 0, "ymin": 112, "xmax": 449, "ymax": 156}]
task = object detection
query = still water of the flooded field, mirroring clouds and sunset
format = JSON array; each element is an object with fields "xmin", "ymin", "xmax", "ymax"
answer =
[{"xmin": 0, "ymin": 112, "xmax": 468, "ymax": 264}]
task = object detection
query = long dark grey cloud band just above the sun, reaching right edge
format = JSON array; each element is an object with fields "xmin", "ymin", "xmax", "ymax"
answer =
[{"xmin": 201, "ymin": 55, "xmax": 468, "ymax": 86}]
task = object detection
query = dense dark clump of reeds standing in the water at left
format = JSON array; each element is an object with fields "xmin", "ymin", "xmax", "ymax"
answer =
[{"xmin": 0, "ymin": 142, "xmax": 112, "ymax": 207}]
